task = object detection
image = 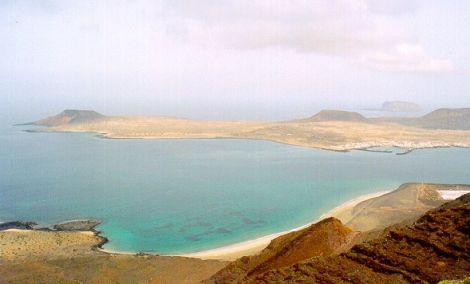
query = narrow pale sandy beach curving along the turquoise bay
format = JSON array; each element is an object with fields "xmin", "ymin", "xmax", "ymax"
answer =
[{"xmin": 178, "ymin": 191, "xmax": 390, "ymax": 260}]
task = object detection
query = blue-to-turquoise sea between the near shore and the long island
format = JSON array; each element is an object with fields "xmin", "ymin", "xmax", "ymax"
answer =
[{"xmin": 0, "ymin": 127, "xmax": 470, "ymax": 253}]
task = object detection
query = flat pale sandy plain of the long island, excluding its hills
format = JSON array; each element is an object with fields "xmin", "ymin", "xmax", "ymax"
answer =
[{"xmin": 35, "ymin": 116, "xmax": 470, "ymax": 151}]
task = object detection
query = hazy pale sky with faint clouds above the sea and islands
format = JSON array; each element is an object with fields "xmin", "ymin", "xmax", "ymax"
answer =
[{"xmin": 0, "ymin": 0, "xmax": 470, "ymax": 122}]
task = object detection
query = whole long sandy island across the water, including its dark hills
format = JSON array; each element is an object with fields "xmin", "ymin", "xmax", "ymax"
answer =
[{"xmin": 23, "ymin": 108, "xmax": 470, "ymax": 151}]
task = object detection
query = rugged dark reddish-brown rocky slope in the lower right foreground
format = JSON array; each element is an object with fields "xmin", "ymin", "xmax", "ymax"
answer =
[{"xmin": 211, "ymin": 194, "xmax": 470, "ymax": 283}]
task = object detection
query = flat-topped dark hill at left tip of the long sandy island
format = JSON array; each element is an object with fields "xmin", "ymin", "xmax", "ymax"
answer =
[{"xmin": 32, "ymin": 109, "xmax": 106, "ymax": 126}]
